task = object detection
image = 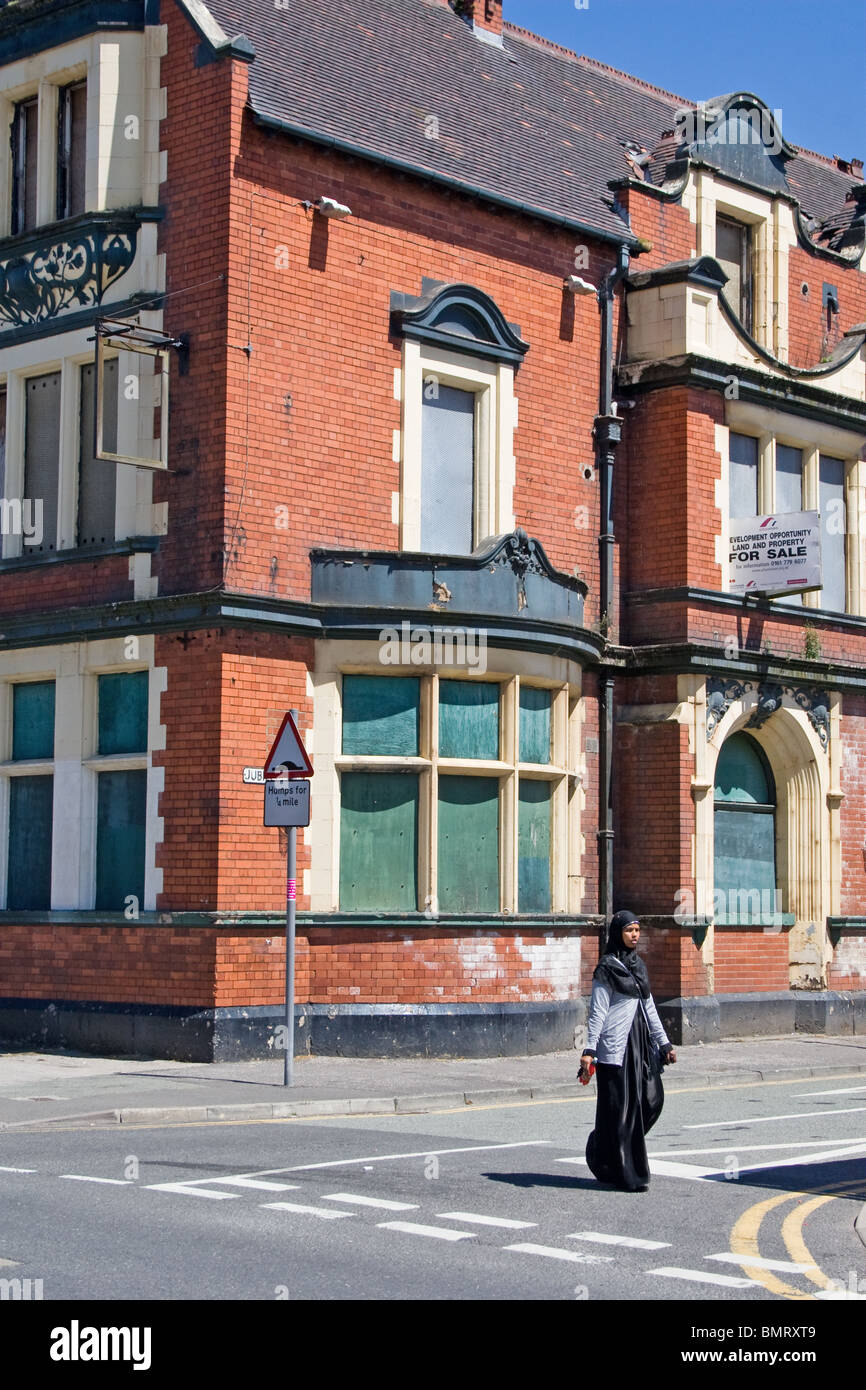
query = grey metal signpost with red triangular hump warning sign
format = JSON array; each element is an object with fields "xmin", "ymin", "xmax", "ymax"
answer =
[{"xmin": 264, "ymin": 709, "xmax": 313, "ymax": 1086}]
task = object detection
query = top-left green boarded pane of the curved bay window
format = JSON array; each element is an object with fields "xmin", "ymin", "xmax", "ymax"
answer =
[{"xmin": 343, "ymin": 676, "xmax": 421, "ymax": 758}]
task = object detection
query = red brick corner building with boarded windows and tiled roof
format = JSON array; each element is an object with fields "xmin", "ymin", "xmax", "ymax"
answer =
[{"xmin": 0, "ymin": 0, "xmax": 866, "ymax": 1058}]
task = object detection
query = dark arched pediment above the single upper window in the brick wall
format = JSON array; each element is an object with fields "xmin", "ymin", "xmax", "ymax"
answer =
[{"xmin": 391, "ymin": 281, "xmax": 530, "ymax": 367}]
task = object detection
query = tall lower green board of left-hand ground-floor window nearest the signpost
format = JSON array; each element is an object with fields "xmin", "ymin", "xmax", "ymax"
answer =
[{"xmin": 96, "ymin": 770, "xmax": 147, "ymax": 912}]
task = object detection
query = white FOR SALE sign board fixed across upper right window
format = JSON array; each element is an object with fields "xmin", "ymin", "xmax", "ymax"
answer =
[{"xmin": 728, "ymin": 512, "xmax": 822, "ymax": 598}]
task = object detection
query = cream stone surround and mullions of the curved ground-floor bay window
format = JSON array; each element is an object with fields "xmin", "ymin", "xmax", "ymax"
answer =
[{"xmin": 303, "ymin": 642, "xmax": 585, "ymax": 919}]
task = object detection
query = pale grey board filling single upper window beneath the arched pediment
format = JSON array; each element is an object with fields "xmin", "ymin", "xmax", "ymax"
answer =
[{"xmin": 421, "ymin": 384, "xmax": 475, "ymax": 555}]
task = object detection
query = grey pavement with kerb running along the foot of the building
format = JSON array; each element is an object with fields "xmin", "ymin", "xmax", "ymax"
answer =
[{"xmin": 0, "ymin": 1033, "xmax": 866, "ymax": 1128}]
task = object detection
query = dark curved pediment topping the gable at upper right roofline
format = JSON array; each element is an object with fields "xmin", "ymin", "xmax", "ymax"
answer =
[{"xmin": 677, "ymin": 92, "xmax": 796, "ymax": 193}]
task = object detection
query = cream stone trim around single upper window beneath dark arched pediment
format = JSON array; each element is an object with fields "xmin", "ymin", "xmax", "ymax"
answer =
[{"xmin": 395, "ymin": 339, "xmax": 514, "ymax": 550}]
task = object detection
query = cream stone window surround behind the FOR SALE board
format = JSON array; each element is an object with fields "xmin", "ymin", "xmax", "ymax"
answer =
[{"xmin": 716, "ymin": 400, "xmax": 866, "ymax": 616}]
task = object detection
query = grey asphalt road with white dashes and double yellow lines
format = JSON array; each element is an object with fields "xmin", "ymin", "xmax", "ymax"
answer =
[{"xmin": 0, "ymin": 1076, "xmax": 866, "ymax": 1308}]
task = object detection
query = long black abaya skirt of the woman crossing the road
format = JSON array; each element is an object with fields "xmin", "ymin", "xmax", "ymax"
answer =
[{"xmin": 587, "ymin": 1008, "xmax": 664, "ymax": 1193}]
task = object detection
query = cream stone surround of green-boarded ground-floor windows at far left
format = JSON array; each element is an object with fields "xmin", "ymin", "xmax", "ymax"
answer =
[{"xmin": 0, "ymin": 637, "xmax": 165, "ymax": 912}]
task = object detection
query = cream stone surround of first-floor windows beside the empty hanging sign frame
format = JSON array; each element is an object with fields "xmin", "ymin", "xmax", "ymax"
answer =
[{"xmin": 0, "ymin": 329, "xmax": 159, "ymax": 560}]
